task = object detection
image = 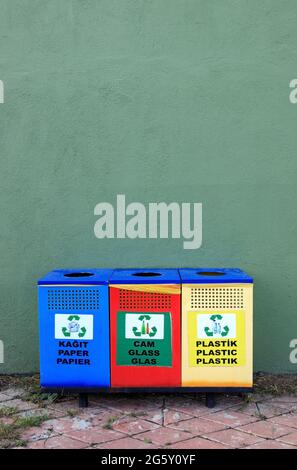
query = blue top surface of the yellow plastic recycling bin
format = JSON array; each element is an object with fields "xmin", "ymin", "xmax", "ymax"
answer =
[{"xmin": 179, "ymin": 268, "xmax": 253, "ymax": 284}]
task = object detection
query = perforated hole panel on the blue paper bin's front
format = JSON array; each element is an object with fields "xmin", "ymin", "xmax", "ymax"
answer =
[{"xmin": 47, "ymin": 288, "xmax": 99, "ymax": 311}]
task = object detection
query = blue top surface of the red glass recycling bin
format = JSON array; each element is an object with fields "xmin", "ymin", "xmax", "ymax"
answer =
[{"xmin": 110, "ymin": 268, "xmax": 180, "ymax": 284}]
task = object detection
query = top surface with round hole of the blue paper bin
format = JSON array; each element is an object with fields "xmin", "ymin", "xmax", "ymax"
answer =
[{"xmin": 38, "ymin": 268, "xmax": 113, "ymax": 285}]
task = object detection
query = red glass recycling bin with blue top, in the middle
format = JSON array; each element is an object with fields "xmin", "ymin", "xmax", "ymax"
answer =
[{"xmin": 110, "ymin": 269, "xmax": 181, "ymax": 389}]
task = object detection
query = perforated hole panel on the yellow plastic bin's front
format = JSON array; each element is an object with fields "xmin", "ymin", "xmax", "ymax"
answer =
[{"xmin": 191, "ymin": 287, "xmax": 244, "ymax": 309}]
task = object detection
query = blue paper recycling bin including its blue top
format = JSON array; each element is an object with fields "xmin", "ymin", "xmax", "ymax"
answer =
[{"xmin": 38, "ymin": 269, "xmax": 112, "ymax": 389}]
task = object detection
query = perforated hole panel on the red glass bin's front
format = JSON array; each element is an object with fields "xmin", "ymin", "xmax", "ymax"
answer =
[{"xmin": 120, "ymin": 289, "xmax": 171, "ymax": 310}]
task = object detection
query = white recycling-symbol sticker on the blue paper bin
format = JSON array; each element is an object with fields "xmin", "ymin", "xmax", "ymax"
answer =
[{"xmin": 55, "ymin": 313, "xmax": 93, "ymax": 340}]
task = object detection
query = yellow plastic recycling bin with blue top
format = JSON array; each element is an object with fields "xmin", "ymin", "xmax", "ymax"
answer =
[{"xmin": 179, "ymin": 268, "xmax": 253, "ymax": 391}]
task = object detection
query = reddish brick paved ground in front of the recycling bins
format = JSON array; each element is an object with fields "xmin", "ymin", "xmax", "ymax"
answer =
[{"xmin": 0, "ymin": 387, "xmax": 297, "ymax": 449}]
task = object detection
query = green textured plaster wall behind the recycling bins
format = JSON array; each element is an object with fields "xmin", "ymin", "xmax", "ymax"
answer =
[{"xmin": 0, "ymin": 0, "xmax": 297, "ymax": 372}]
